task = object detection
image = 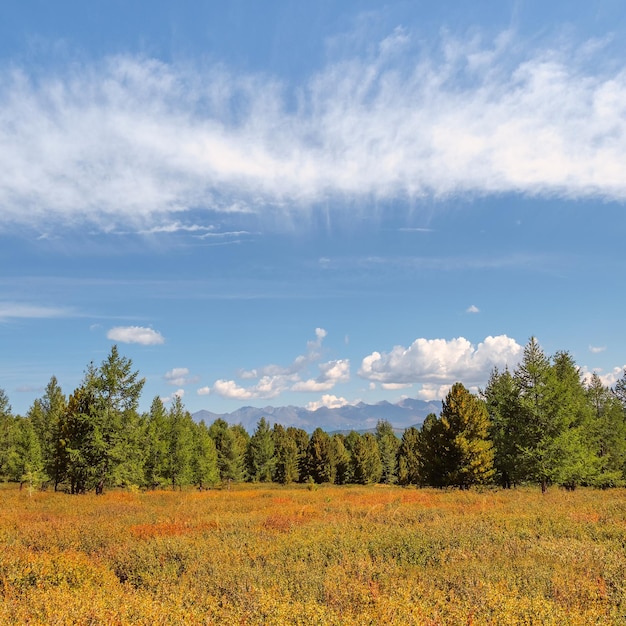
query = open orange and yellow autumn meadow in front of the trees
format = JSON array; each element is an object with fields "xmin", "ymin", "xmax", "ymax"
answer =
[{"xmin": 0, "ymin": 485, "xmax": 626, "ymax": 626}]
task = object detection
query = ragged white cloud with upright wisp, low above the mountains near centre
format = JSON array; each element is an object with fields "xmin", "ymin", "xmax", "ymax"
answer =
[{"xmin": 208, "ymin": 328, "xmax": 350, "ymax": 400}]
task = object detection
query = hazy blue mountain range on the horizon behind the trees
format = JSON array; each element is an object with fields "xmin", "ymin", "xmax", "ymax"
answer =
[{"xmin": 192, "ymin": 398, "xmax": 441, "ymax": 433}]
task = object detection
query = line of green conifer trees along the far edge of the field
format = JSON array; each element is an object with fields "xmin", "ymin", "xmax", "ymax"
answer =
[{"xmin": 0, "ymin": 338, "xmax": 626, "ymax": 493}]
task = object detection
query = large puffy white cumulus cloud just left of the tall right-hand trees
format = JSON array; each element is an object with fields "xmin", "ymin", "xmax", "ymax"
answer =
[{"xmin": 359, "ymin": 335, "xmax": 523, "ymax": 385}]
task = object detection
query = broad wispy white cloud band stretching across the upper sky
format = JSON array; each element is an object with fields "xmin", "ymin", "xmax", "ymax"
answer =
[{"xmin": 0, "ymin": 31, "xmax": 626, "ymax": 235}]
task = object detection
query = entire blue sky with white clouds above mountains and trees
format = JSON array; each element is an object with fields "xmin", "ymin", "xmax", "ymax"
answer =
[{"xmin": 0, "ymin": 0, "xmax": 626, "ymax": 420}]
